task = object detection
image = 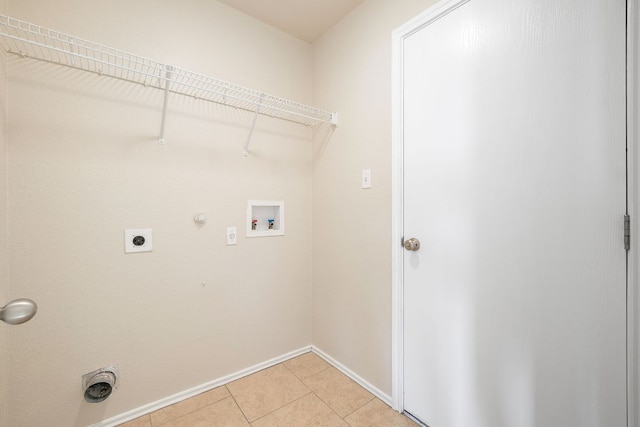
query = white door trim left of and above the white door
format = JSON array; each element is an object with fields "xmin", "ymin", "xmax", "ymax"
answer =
[{"xmin": 391, "ymin": 0, "xmax": 470, "ymax": 412}]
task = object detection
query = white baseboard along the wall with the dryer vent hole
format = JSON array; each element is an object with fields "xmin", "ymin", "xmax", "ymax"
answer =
[{"xmin": 91, "ymin": 346, "xmax": 312, "ymax": 427}]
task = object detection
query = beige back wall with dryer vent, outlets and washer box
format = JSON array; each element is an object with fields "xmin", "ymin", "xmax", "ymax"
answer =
[{"xmin": 5, "ymin": 0, "xmax": 312, "ymax": 426}]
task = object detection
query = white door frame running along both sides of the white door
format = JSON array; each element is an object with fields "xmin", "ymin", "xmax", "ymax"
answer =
[{"xmin": 391, "ymin": 0, "xmax": 640, "ymax": 427}]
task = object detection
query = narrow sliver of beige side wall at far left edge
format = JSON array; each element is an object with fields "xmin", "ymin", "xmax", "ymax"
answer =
[{"xmin": 0, "ymin": 0, "xmax": 9, "ymax": 426}]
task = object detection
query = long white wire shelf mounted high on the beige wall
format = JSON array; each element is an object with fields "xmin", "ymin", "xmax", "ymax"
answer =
[{"xmin": 0, "ymin": 15, "xmax": 337, "ymax": 145}]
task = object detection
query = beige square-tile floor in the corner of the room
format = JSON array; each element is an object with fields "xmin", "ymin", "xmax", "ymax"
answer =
[{"xmin": 120, "ymin": 353, "xmax": 417, "ymax": 427}]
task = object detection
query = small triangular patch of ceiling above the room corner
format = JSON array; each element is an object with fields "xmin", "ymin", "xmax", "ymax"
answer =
[{"xmin": 219, "ymin": 0, "xmax": 363, "ymax": 43}]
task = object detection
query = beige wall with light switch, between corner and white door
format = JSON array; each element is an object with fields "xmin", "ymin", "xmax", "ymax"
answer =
[{"xmin": 313, "ymin": 0, "xmax": 435, "ymax": 395}]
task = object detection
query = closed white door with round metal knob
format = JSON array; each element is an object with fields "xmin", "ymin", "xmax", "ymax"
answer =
[{"xmin": 402, "ymin": 0, "xmax": 627, "ymax": 427}]
